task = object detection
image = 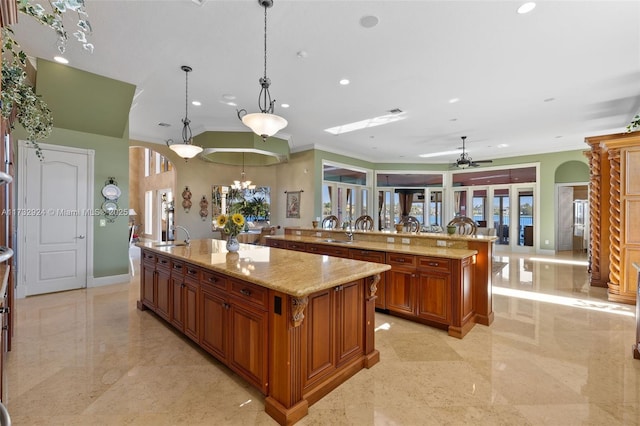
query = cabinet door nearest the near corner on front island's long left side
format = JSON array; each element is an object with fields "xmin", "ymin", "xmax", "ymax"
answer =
[{"xmin": 229, "ymin": 299, "xmax": 269, "ymax": 393}]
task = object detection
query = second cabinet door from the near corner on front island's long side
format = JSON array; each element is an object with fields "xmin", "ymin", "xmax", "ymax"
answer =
[{"xmin": 200, "ymin": 288, "xmax": 229, "ymax": 363}]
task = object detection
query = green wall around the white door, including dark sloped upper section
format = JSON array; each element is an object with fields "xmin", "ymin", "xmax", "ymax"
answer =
[{"xmin": 12, "ymin": 59, "xmax": 135, "ymax": 278}]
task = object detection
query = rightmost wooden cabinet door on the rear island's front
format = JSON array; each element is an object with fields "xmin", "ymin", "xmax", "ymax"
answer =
[{"xmin": 417, "ymin": 271, "xmax": 451, "ymax": 324}]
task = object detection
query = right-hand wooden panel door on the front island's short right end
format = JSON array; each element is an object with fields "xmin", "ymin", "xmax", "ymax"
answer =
[{"xmin": 335, "ymin": 280, "xmax": 364, "ymax": 367}]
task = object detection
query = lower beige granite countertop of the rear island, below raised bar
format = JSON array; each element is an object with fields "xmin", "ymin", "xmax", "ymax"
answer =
[{"xmin": 266, "ymin": 235, "xmax": 478, "ymax": 259}]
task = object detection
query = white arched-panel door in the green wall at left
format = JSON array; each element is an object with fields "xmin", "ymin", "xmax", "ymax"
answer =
[{"xmin": 17, "ymin": 143, "xmax": 93, "ymax": 296}]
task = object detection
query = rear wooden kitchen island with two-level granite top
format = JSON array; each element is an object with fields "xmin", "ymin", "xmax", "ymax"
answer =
[{"xmin": 267, "ymin": 228, "xmax": 484, "ymax": 338}]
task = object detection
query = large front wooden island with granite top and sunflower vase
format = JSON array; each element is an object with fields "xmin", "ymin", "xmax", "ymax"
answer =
[{"xmin": 137, "ymin": 240, "xmax": 390, "ymax": 424}]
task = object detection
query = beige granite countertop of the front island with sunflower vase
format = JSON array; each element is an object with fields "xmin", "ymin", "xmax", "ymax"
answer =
[{"xmin": 136, "ymin": 239, "xmax": 391, "ymax": 297}]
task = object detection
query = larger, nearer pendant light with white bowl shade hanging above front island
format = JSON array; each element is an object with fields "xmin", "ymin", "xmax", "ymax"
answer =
[{"xmin": 236, "ymin": 0, "xmax": 287, "ymax": 141}]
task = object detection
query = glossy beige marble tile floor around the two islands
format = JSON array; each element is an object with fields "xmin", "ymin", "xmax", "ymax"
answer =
[{"xmin": 5, "ymin": 248, "xmax": 640, "ymax": 425}]
